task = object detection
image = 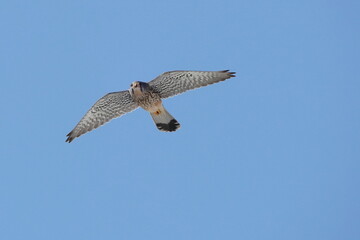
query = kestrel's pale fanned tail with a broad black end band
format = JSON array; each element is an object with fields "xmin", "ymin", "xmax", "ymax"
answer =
[{"xmin": 150, "ymin": 105, "xmax": 180, "ymax": 132}]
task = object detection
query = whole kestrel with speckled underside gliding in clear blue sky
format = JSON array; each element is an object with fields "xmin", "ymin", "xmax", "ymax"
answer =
[{"xmin": 66, "ymin": 70, "xmax": 235, "ymax": 143}]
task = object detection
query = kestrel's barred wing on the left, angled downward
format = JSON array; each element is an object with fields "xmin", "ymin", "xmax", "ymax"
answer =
[{"xmin": 66, "ymin": 91, "xmax": 138, "ymax": 143}]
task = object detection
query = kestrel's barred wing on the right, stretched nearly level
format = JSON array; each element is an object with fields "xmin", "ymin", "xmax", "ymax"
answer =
[{"xmin": 149, "ymin": 70, "xmax": 235, "ymax": 98}]
